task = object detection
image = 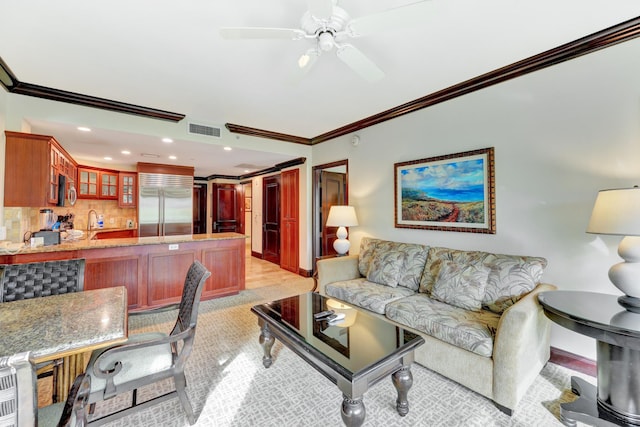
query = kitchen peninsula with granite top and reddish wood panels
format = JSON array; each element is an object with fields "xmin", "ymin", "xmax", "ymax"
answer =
[{"xmin": 0, "ymin": 234, "xmax": 247, "ymax": 310}]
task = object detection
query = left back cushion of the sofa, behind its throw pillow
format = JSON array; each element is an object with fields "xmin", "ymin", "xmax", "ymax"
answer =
[{"xmin": 358, "ymin": 237, "xmax": 429, "ymax": 291}]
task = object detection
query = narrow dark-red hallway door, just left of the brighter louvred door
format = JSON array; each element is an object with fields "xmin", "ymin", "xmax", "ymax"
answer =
[{"xmin": 262, "ymin": 175, "xmax": 280, "ymax": 265}]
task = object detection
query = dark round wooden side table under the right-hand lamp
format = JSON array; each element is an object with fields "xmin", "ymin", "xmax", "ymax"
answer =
[{"xmin": 538, "ymin": 291, "xmax": 640, "ymax": 427}]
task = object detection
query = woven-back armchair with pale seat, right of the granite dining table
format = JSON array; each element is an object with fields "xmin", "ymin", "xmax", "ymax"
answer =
[{"xmin": 87, "ymin": 261, "xmax": 211, "ymax": 424}]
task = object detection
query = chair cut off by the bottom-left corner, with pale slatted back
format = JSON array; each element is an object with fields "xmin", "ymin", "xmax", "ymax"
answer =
[{"xmin": 0, "ymin": 352, "xmax": 91, "ymax": 427}]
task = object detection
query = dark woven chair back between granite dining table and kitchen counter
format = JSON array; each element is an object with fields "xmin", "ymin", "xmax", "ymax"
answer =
[{"xmin": 0, "ymin": 258, "xmax": 85, "ymax": 302}]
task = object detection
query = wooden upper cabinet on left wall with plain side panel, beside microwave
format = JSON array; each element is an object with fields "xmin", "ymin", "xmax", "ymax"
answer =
[{"xmin": 4, "ymin": 131, "xmax": 77, "ymax": 207}]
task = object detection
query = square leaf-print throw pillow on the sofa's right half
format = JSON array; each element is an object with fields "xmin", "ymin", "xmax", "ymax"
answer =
[{"xmin": 431, "ymin": 260, "xmax": 490, "ymax": 310}]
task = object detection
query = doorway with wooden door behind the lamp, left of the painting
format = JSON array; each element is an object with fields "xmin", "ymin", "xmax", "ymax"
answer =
[{"xmin": 311, "ymin": 160, "xmax": 349, "ymax": 264}]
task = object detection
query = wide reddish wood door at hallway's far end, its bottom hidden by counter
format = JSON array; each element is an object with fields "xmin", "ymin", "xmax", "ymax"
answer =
[{"xmin": 211, "ymin": 184, "xmax": 242, "ymax": 233}]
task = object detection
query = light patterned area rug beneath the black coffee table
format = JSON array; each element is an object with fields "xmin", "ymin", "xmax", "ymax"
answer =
[{"xmin": 89, "ymin": 285, "xmax": 595, "ymax": 427}]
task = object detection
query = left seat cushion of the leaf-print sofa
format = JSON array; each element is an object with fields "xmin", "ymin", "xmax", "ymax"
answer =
[{"xmin": 325, "ymin": 277, "xmax": 414, "ymax": 314}]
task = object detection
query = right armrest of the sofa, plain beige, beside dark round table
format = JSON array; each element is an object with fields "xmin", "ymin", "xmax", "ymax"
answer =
[{"xmin": 493, "ymin": 283, "xmax": 556, "ymax": 409}]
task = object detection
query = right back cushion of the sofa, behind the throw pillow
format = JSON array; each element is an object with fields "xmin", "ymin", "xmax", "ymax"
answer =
[{"xmin": 419, "ymin": 247, "xmax": 547, "ymax": 314}]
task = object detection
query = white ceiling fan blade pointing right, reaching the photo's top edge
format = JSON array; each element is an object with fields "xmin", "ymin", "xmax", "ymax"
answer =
[{"xmin": 347, "ymin": 0, "xmax": 438, "ymax": 37}]
